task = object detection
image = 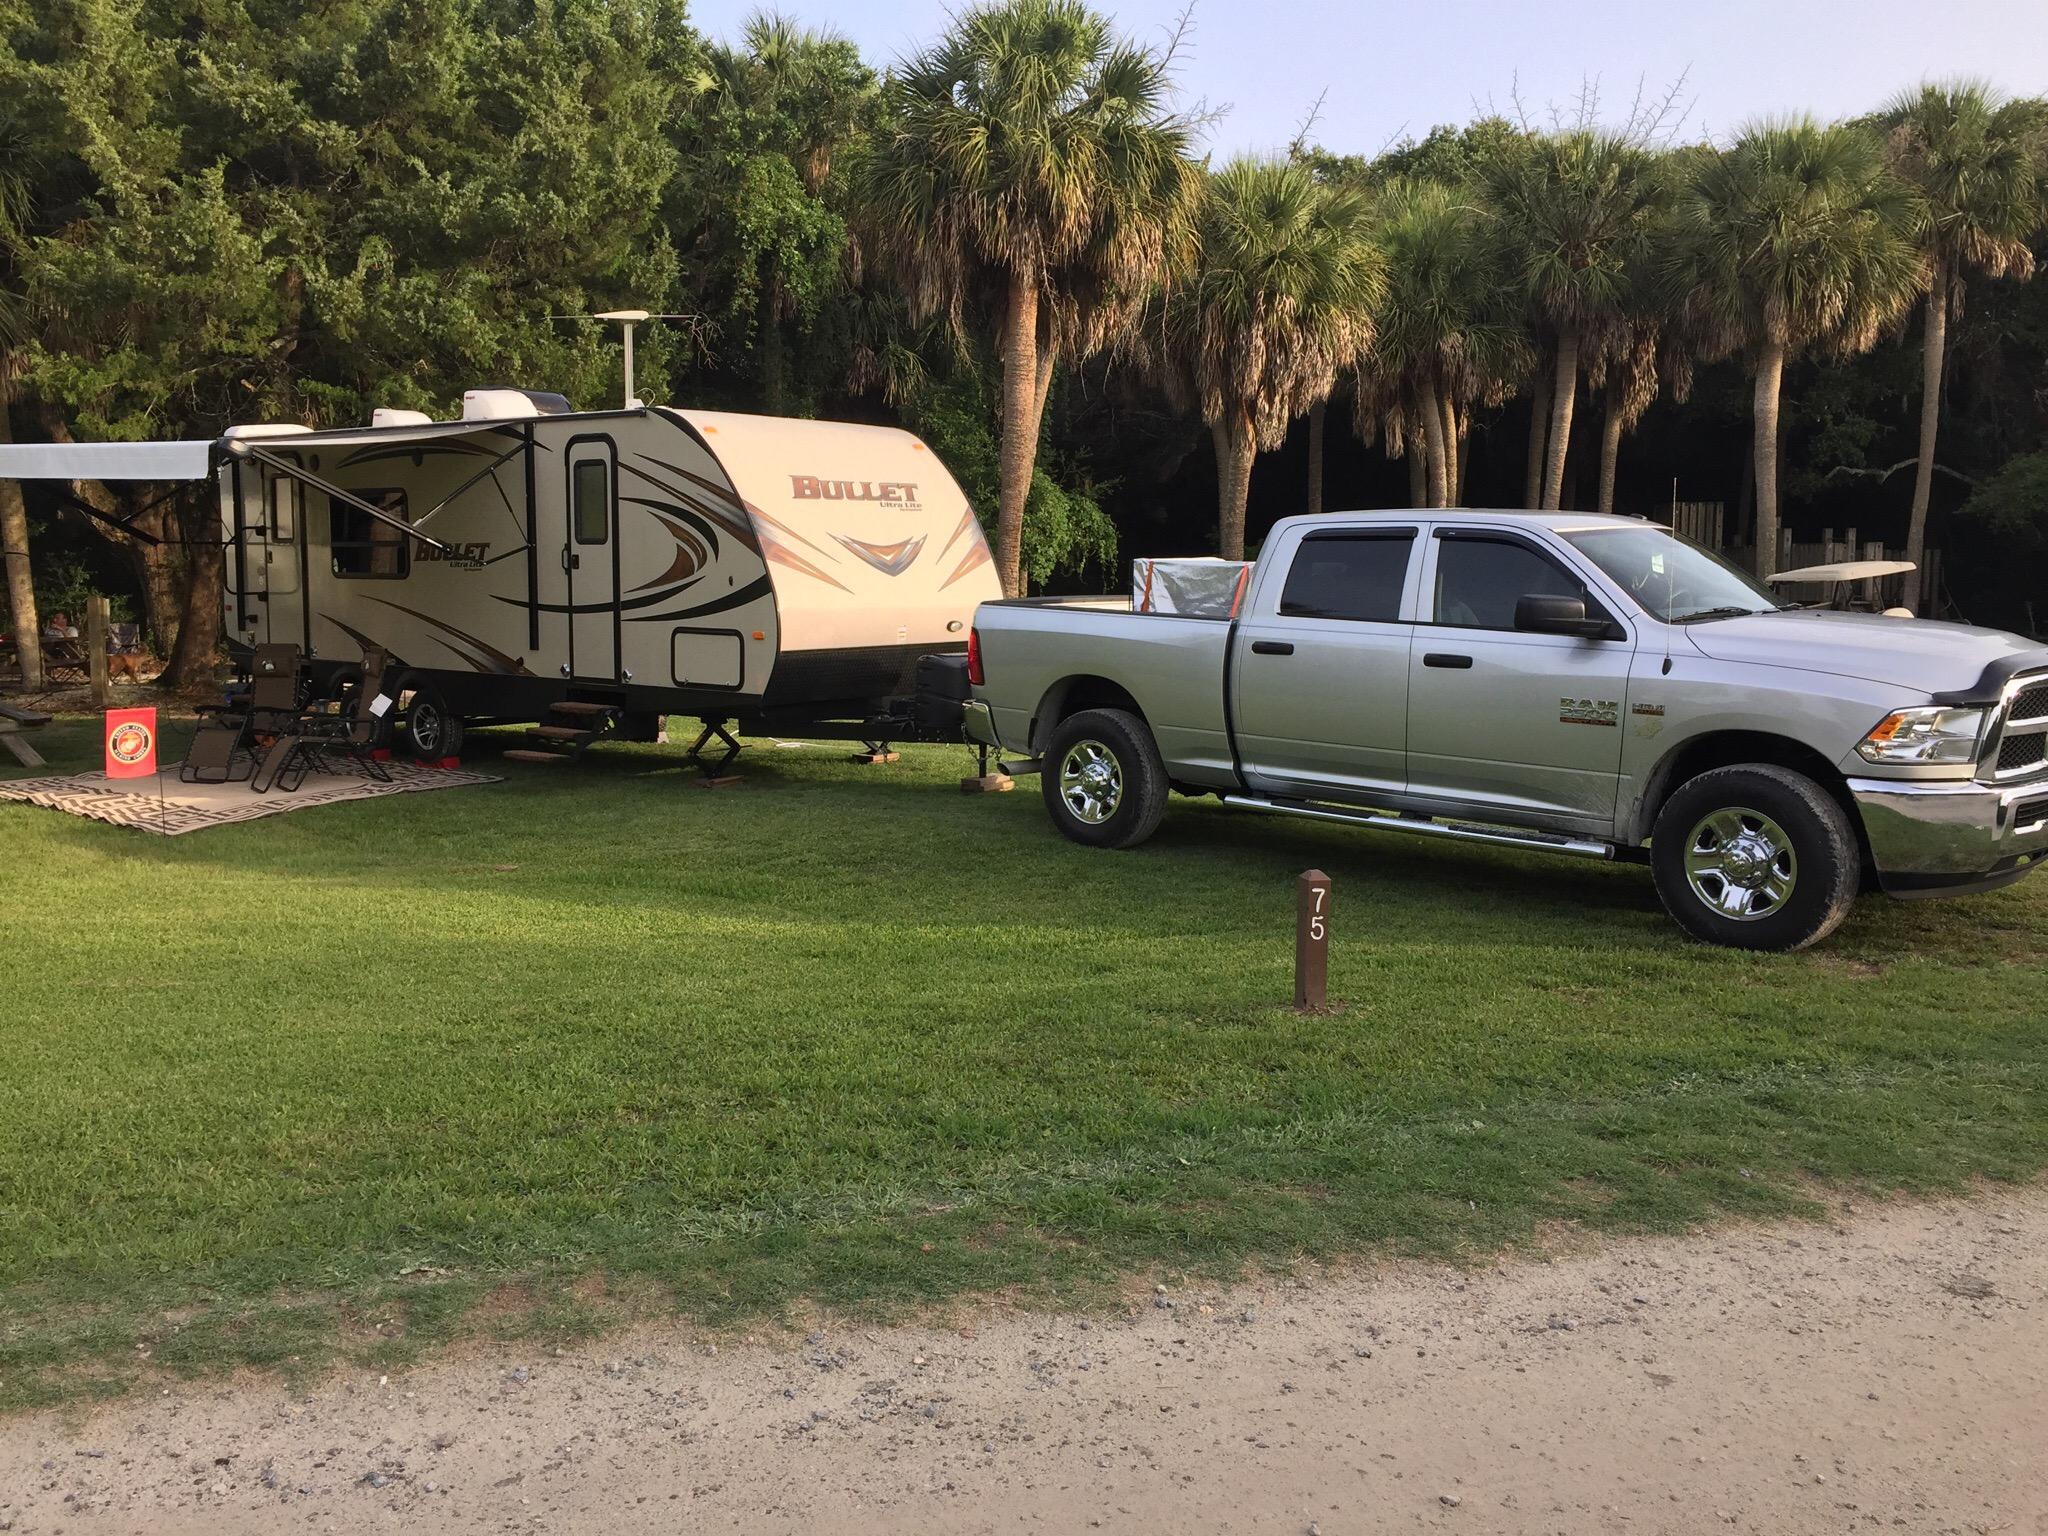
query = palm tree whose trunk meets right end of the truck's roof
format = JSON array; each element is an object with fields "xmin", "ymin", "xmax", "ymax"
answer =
[{"xmin": 1487, "ymin": 129, "xmax": 1659, "ymax": 510}]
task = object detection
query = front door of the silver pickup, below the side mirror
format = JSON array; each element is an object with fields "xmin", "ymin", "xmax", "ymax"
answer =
[{"xmin": 1409, "ymin": 528, "xmax": 1634, "ymax": 821}]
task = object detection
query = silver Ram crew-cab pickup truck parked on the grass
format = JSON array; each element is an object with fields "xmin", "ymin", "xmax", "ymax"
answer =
[{"xmin": 967, "ymin": 510, "xmax": 2048, "ymax": 950}]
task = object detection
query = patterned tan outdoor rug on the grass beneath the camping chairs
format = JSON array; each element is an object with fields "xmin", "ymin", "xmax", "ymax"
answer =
[{"xmin": 0, "ymin": 762, "xmax": 500, "ymax": 838}]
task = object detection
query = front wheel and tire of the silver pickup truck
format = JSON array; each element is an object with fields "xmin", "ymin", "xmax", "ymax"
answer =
[{"xmin": 1651, "ymin": 762, "xmax": 1862, "ymax": 952}]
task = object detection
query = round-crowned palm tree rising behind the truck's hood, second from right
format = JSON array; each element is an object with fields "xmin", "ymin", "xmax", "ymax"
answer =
[{"xmin": 1667, "ymin": 119, "xmax": 1925, "ymax": 575}]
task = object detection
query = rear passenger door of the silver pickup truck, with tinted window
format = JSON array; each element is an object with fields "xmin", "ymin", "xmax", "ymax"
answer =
[{"xmin": 1231, "ymin": 528, "xmax": 1417, "ymax": 799}]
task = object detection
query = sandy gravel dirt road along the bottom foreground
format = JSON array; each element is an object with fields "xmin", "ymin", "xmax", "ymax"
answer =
[{"xmin": 0, "ymin": 1188, "xmax": 2048, "ymax": 1536}]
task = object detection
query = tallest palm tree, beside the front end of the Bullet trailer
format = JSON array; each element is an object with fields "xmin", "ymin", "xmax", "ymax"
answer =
[{"xmin": 860, "ymin": 0, "xmax": 1202, "ymax": 594}]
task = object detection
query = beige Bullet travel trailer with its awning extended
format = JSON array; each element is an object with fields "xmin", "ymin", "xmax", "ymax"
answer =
[{"xmin": 0, "ymin": 389, "xmax": 1001, "ymax": 758}]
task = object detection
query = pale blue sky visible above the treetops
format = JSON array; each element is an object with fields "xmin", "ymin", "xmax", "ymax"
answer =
[{"xmin": 692, "ymin": 0, "xmax": 2048, "ymax": 154}]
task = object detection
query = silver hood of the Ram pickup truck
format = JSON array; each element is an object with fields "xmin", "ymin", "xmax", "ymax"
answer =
[{"xmin": 1681, "ymin": 608, "xmax": 2048, "ymax": 694}]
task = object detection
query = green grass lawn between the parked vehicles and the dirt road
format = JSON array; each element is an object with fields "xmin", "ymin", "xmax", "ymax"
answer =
[{"xmin": 0, "ymin": 708, "xmax": 2048, "ymax": 1405}]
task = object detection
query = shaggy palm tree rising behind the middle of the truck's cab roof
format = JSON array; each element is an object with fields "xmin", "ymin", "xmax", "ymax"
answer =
[{"xmin": 1354, "ymin": 180, "xmax": 1528, "ymax": 506}]
